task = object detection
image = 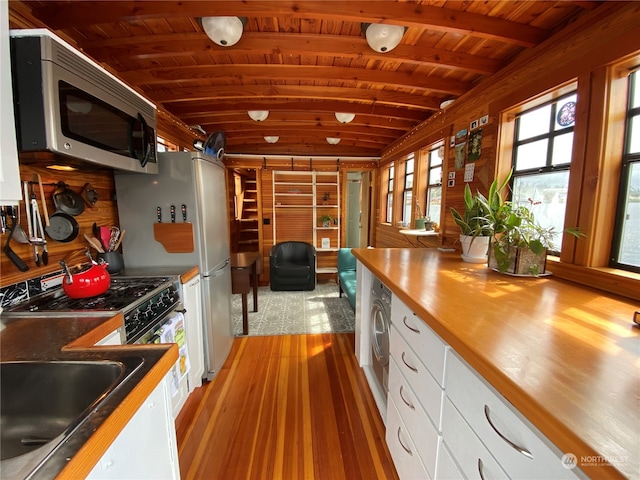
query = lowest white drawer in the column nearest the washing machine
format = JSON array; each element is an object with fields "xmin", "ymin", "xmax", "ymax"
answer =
[{"xmin": 385, "ymin": 400, "xmax": 431, "ymax": 480}]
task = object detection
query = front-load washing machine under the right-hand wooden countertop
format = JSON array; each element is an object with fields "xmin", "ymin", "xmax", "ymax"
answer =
[{"xmin": 370, "ymin": 277, "xmax": 391, "ymax": 405}]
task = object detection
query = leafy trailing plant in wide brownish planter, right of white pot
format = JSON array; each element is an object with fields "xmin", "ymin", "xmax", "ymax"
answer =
[{"xmin": 478, "ymin": 171, "xmax": 583, "ymax": 276}]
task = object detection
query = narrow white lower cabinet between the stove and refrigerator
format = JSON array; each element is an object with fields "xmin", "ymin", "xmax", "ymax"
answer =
[{"xmin": 182, "ymin": 275, "xmax": 204, "ymax": 392}]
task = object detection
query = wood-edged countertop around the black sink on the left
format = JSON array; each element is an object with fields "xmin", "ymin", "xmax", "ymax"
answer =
[{"xmin": 0, "ymin": 314, "xmax": 178, "ymax": 480}]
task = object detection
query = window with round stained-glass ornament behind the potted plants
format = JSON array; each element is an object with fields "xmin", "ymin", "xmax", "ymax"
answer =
[{"xmin": 512, "ymin": 92, "xmax": 577, "ymax": 254}]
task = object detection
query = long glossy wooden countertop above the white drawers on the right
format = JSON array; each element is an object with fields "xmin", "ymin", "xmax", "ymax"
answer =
[{"xmin": 353, "ymin": 249, "xmax": 640, "ymax": 479}]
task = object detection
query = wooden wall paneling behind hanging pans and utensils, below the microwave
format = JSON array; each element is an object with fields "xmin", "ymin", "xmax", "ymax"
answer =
[{"xmin": 0, "ymin": 160, "xmax": 118, "ymax": 287}]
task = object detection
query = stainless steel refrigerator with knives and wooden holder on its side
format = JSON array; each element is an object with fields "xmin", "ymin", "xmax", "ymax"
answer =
[{"xmin": 115, "ymin": 152, "xmax": 233, "ymax": 380}]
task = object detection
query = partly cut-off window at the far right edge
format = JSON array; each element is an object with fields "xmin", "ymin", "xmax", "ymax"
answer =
[{"xmin": 611, "ymin": 71, "xmax": 640, "ymax": 272}]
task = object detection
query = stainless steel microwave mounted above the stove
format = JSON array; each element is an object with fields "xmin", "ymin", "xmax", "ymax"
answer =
[{"xmin": 10, "ymin": 29, "xmax": 158, "ymax": 173}]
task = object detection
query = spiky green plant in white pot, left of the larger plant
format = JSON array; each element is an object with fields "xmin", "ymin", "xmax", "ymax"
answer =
[{"xmin": 451, "ymin": 183, "xmax": 493, "ymax": 263}]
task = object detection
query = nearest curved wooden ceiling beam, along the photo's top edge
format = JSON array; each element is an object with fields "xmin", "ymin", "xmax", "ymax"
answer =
[{"xmin": 27, "ymin": 0, "xmax": 547, "ymax": 47}]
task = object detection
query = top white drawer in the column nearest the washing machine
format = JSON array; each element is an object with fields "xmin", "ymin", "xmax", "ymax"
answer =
[{"xmin": 391, "ymin": 296, "xmax": 449, "ymax": 386}]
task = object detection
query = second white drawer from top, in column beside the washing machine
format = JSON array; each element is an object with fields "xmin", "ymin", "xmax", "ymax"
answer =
[{"xmin": 389, "ymin": 324, "xmax": 444, "ymax": 432}]
